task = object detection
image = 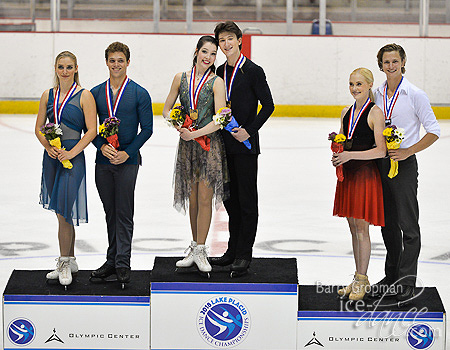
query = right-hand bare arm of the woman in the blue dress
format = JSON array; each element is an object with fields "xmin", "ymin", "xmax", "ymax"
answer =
[{"xmin": 58, "ymin": 90, "xmax": 97, "ymax": 161}]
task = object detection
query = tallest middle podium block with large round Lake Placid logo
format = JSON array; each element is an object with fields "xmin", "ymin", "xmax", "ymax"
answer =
[{"xmin": 151, "ymin": 257, "xmax": 298, "ymax": 350}]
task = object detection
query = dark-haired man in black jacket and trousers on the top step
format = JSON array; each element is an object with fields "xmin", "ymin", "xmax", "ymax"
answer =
[{"xmin": 210, "ymin": 21, "xmax": 274, "ymax": 276}]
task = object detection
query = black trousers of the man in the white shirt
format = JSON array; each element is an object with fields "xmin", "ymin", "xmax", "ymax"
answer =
[{"xmin": 378, "ymin": 155, "xmax": 421, "ymax": 286}]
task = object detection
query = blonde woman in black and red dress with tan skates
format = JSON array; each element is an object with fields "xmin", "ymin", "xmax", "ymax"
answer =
[{"xmin": 332, "ymin": 68, "xmax": 386, "ymax": 300}]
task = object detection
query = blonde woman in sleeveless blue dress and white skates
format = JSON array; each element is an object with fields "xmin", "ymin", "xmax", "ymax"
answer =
[{"xmin": 35, "ymin": 51, "xmax": 97, "ymax": 288}]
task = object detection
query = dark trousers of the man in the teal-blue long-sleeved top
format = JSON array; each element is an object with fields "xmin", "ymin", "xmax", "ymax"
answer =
[{"xmin": 95, "ymin": 164, "xmax": 139, "ymax": 268}]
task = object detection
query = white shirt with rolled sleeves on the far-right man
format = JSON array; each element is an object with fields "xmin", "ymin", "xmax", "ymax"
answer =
[{"xmin": 374, "ymin": 77, "xmax": 441, "ymax": 148}]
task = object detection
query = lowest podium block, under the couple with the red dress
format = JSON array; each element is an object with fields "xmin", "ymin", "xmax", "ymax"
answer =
[{"xmin": 297, "ymin": 285, "xmax": 446, "ymax": 350}]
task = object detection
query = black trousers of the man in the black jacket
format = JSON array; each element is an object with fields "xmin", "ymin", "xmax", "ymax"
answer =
[{"xmin": 224, "ymin": 154, "xmax": 258, "ymax": 260}]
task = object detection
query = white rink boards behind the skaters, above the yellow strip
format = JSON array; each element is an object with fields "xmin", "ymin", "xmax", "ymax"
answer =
[{"xmin": 0, "ymin": 33, "xmax": 450, "ymax": 105}]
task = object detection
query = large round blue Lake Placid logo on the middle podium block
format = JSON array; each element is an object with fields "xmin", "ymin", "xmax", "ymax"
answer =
[{"xmin": 197, "ymin": 296, "xmax": 251, "ymax": 348}]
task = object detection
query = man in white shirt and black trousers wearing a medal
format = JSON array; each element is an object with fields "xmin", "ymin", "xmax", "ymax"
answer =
[{"xmin": 372, "ymin": 44, "xmax": 440, "ymax": 302}]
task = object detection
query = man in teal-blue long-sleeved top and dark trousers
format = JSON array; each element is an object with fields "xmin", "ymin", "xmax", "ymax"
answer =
[{"xmin": 91, "ymin": 42, "xmax": 153, "ymax": 284}]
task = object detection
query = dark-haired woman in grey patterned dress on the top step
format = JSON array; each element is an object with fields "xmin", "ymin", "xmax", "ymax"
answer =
[{"xmin": 163, "ymin": 35, "xmax": 228, "ymax": 274}]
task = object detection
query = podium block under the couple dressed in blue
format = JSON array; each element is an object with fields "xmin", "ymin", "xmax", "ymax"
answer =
[{"xmin": 3, "ymin": 270, "xmax": 150, "ymax": 349}]
